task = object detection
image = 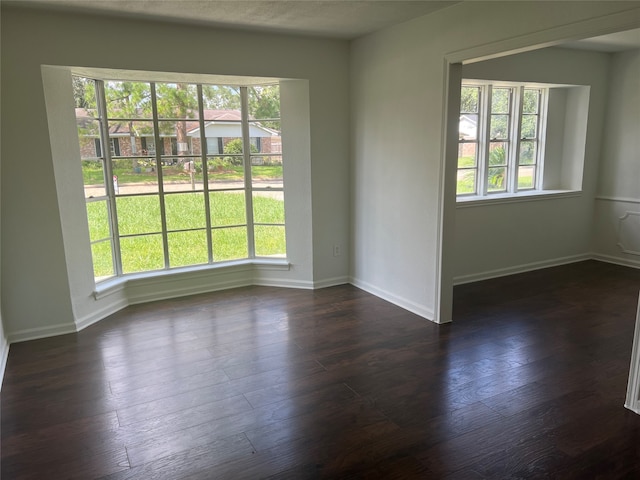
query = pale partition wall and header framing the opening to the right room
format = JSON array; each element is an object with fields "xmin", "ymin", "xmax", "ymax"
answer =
[{"xmin": 351, "ymin": 2, "xmax": 639, "ymax": 322}]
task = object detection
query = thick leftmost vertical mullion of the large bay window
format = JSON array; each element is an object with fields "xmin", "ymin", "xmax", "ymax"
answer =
[{"xmin": 95, "ymin": 80, "xmax": 122, "ymax": 276}]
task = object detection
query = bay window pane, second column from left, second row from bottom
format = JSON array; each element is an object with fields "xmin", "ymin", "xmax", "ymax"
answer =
[{"xmin": 116, "ymin": 195, "xmax": 162, "ymax": 235}]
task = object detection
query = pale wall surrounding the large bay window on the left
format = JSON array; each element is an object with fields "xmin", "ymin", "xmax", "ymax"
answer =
[{"xmin": 1, "ymin": 7, "xmax": 349, "ymax": 341}]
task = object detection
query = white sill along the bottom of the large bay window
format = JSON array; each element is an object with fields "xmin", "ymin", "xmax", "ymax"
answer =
[{"xmin": 93, "ymin": 258, "xmax": 291, "ymax": 300}]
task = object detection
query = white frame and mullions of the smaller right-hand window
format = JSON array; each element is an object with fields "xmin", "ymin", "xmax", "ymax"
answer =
[{"xmin": 456, "ymin": 79, "xmax": 549, "ymax": 201}]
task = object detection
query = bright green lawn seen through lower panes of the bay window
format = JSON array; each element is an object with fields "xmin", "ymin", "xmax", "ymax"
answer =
[{"xmin": 87, "ymin": 192, "xmax": 286, "ymax": 277}]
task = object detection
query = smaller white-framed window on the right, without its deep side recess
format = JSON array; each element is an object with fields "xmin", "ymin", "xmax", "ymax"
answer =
[{"xmin": 457, "ymin": 82, "xmax": 548, "ymax": 196}]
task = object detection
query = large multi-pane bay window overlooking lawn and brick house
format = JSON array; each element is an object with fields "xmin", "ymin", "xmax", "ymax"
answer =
[{"xmin": 74, "ymin": 77, "xmax": 286, "ymax": 281}]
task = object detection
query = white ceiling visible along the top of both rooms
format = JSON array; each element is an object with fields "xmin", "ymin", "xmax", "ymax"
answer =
[{"xmin": 5, "ymin": 0, "xmax": 640, "ymax": 48}]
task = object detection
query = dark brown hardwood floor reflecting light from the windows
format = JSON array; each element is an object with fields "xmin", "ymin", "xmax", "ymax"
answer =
[{"xmin": 1, "ymin": 261, "xmax": 640, "ymax": 480}]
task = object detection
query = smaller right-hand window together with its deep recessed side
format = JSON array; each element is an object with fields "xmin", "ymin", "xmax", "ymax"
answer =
[{"xmin": 456, "ymin": 79, "xmax": 590, "ymax": 202}]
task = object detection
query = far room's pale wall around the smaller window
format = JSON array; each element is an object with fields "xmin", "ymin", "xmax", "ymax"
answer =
[{"xmin": 454, "ymin": 48, "xmax": 610, "ymax": 282}]
